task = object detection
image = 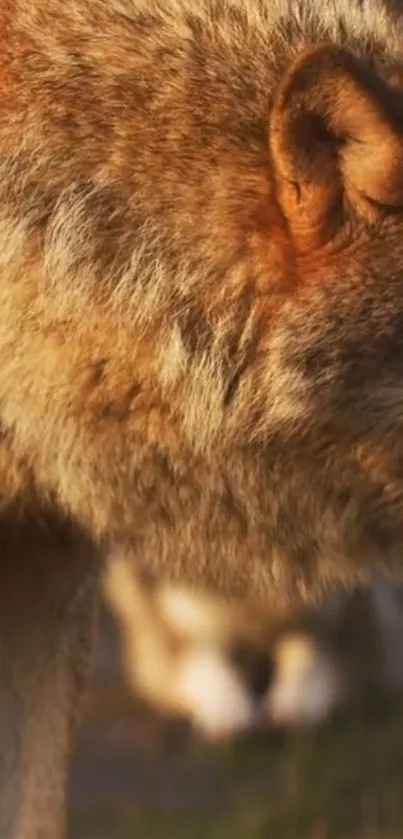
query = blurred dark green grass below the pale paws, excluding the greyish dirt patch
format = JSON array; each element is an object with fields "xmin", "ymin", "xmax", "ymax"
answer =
[{"xmin": 70, "ymin": 705, "xmax": 403, "ymax": 839}]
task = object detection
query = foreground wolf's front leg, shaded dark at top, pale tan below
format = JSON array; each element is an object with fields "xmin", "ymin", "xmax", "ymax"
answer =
[{"xmin": 0, "ymin": 522, "xmax": 100, "ymax": 839}]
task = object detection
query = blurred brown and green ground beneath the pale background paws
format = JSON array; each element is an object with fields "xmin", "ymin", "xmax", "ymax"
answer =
[{"xmin": 69, "ymin": 612, "xmax": 403, "ymax": 839}]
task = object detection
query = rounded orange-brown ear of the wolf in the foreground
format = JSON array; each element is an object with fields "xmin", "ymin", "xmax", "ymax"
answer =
[{"xmin": 270, "ymin": 47, "xmax": 403, "ymax": 250}]
